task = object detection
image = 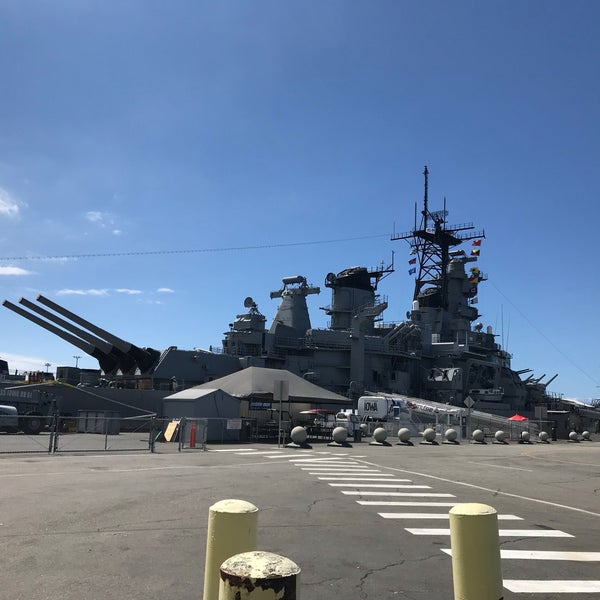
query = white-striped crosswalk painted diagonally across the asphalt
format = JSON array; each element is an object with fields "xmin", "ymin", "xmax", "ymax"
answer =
[{"xmin": 280, "ymin": 453, "xmax": 600, "ymax": 597}]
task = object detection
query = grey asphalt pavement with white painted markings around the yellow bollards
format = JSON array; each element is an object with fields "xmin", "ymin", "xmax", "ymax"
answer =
[{"xmin": 0, "ymin": 436, "xmax": 600, "ymax": 600}]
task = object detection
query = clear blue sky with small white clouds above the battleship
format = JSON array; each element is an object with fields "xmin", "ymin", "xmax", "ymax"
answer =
[{"xmin": 0, "ymin": 0, "xmax": 600, "ymax": 399}]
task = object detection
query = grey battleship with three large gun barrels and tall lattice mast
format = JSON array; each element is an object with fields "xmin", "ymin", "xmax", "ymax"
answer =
[{"xmin": 3, "ymin": 167, "xmax": 556, "ymax": 415}]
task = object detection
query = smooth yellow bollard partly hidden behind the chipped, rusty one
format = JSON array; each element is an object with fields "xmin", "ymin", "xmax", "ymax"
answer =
[{"xmin": 203, "ymin": 500, "xmax": 258, "ymax": 600}]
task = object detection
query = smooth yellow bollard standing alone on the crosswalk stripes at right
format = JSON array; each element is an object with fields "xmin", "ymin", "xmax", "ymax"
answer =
[{"xmin": 450, "ymin": 503, "xmax": 503, "ymax": 600}]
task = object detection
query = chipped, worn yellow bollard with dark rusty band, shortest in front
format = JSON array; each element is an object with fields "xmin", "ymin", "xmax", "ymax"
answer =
[{"xmin": 219, "ymin": 551, "xmax": 300, "ymax": 600}]
